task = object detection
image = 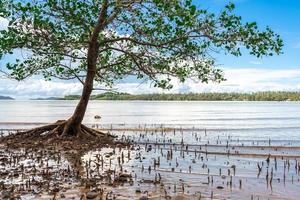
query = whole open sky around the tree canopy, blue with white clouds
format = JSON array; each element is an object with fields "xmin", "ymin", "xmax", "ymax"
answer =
[{"xmin": 0, "ymin": 0, "xmax": 300, "ymax": 99}]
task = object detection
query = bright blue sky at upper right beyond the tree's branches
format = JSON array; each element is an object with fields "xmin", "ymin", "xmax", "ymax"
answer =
[{"xmin": 199, "ymin": 0, "xmax": 300, "ymax": 69}]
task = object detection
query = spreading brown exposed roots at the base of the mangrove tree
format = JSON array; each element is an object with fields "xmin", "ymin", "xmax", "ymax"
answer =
[{"xmin": 0, "ymin": 120, "xmax": 129, "ymax": 184}]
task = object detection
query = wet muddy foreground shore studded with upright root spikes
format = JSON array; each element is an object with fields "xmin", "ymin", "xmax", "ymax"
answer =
[{"xmin": 0, "ymin": 125, "xmax": 300, "ymax": 200}]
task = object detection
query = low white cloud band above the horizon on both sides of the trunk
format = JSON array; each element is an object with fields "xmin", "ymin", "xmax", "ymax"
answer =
[{"xmin": 0, "ymin": 68, "xmax": 300, "ymax": 99}]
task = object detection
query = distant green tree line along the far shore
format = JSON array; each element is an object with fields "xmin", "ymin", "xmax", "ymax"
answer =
[{"xmin": 63, "ymin": 92, "xmax": 300, "ymax": 101}]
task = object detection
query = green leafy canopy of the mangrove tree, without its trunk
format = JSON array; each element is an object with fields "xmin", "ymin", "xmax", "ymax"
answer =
[{"xmin": 0, "ymin": 0, "xmax": 283, "ymax": 89}]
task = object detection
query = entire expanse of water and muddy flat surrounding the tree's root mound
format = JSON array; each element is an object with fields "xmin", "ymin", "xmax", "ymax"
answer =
[{"xmin": 0, "ymin": 100, "xmax": 300, "ymax": 200}]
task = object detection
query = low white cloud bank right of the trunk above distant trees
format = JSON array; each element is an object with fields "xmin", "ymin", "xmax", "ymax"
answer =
[{"xmin": 118, "ymin": 68, "xmax": 300, "ymax": 94}]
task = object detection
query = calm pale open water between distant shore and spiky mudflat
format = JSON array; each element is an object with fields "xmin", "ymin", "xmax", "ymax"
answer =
[{"xmin": 0, "ymin": 100, "xmax": 300, "ymax": 131}]
